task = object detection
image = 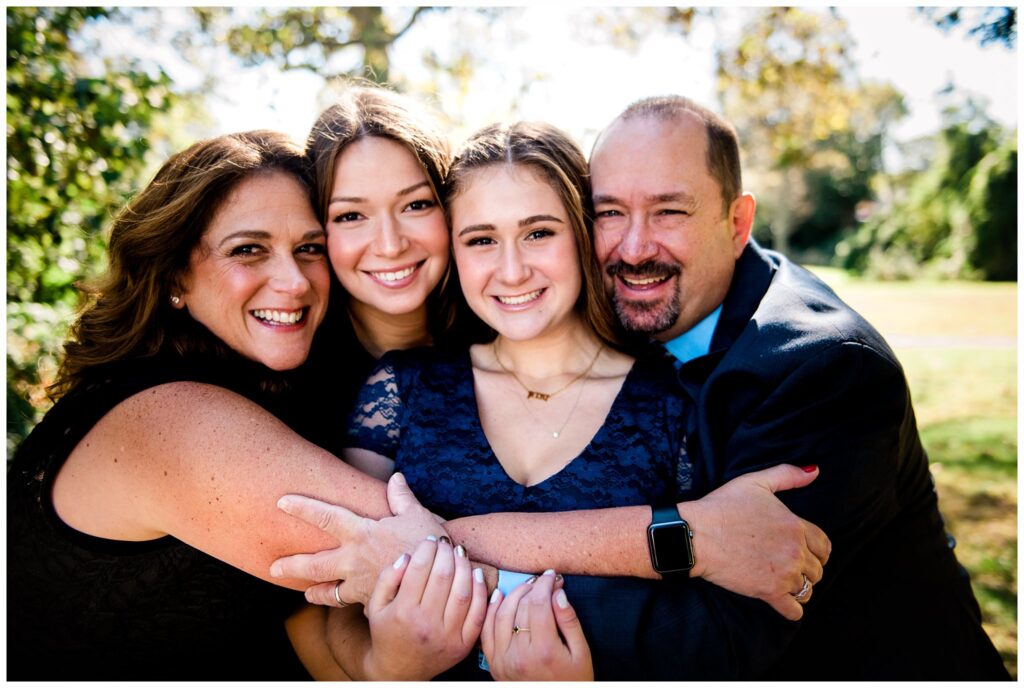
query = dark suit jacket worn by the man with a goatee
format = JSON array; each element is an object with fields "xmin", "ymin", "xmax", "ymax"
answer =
[{"xmin": 567, "ymin": 242, "xmax": 1009, "ymax": 680}]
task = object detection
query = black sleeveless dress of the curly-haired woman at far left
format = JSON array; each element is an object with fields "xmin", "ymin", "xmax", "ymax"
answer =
[{"xmin": 7, "ymin": 344, "xmax": 366, "ymax": 680}]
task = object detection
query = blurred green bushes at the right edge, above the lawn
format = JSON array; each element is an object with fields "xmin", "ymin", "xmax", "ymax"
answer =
[{"xmin": 837, "ymin": 103, "xmax": 1017, "ymax": 280}]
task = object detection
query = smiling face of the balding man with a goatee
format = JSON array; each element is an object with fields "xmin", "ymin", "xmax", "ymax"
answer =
[{"xmin": 590, "ymin": 113, "xmax": 755, "ymax": 341}]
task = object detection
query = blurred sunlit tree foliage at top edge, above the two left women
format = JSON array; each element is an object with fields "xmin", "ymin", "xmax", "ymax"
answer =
[{"xmin": 197, "ymin": 7, "xmax": 431, "ymax": 83}]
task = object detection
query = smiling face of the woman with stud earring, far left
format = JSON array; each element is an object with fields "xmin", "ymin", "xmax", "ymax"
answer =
[{"xmin": 174, "ymin": 172, "xmax": 330, "ymax": 371}]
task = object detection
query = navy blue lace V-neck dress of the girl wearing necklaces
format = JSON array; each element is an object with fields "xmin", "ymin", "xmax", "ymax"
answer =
[{"xmin": 348, "ymin": 348, "xmax": 693, "ymax": 680}]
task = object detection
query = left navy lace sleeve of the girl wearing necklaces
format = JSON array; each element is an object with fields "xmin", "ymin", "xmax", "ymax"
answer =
[{"xmin": 346, "ymin": 351, "xmax": 416, "ymax": 460}]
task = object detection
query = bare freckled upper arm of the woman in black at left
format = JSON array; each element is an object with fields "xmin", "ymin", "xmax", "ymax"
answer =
[{"xmin": 53, "ymin": 382, "xmax": 436, "ymax": 590}]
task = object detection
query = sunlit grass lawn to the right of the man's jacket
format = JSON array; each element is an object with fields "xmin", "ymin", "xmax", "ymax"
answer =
[{"xmin": 812, "ymin": 267, "xmax": 1017, "ymax": 678}]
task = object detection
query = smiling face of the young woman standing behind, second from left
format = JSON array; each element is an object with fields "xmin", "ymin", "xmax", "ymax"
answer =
[{"xmin": 327, "ymin": 136, "xmax": 449, "ymax": 323}]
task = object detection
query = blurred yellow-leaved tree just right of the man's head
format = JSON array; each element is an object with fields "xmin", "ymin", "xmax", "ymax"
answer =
[{"xmin": 718, "ymin": 7, "xmax": 906, "ymax": 253}]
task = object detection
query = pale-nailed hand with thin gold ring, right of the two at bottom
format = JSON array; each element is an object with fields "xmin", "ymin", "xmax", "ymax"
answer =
[{"xmin": 480, "ymin": 570, "xmax": 594, "ymax": 681}]
